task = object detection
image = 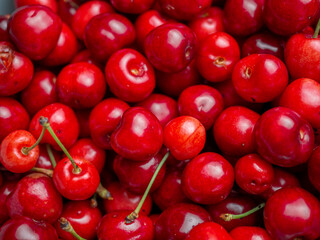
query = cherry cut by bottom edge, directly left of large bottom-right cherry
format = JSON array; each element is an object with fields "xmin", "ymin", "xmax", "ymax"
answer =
[{"xmin": 229, "ymin": 226, "xmax": 272, "ymax": 240}]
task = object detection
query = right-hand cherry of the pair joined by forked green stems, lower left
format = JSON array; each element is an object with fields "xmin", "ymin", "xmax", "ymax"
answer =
[{"xmin": 52, "ymin": 157, "xmax": 100, "ymax": 200}]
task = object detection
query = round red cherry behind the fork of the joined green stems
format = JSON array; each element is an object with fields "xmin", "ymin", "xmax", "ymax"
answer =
[{"xmin": 29, "ymin": 103, "xmax": 79, "ymax": 151}]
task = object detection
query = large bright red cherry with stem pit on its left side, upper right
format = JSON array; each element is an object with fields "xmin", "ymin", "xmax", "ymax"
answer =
[{"xmin": 232, "ymin": 54, "xmax": 288, "ymax": 103}]
